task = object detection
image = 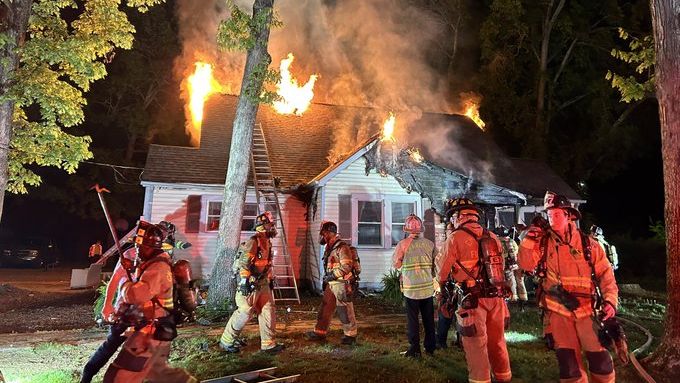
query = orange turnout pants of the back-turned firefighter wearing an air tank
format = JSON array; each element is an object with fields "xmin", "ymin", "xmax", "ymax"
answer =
[{"xmin": 456, "ymin": 298, "xmax": 512, "ymax": 383}]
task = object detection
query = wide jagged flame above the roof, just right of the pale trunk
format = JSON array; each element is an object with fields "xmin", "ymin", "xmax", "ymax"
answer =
[{"xmin": 273, "ymin": 53, "xmax": 319, "ymax": 116}]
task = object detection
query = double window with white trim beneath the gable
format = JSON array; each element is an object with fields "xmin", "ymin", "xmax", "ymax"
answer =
[{"xmin": 350, "ymin": 194, "xmax": 421, "ymax": 249}]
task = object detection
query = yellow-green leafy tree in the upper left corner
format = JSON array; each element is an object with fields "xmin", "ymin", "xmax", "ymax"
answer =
[{"xmin": 0, "ymin": 0, "xmax": 163, "ymax": 222}]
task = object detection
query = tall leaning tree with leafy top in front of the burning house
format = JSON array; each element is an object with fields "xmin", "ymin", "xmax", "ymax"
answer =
[{"xmin": 208, "ymin": 0, "xmax": 277, "ymax": 308}]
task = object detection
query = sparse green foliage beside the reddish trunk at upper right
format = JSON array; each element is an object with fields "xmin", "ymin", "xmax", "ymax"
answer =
[{"xmin": 605, "ymin": 28, "xmax": 655, "ymax": 103}]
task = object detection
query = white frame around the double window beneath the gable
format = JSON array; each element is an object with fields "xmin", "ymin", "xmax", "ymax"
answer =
[{"xmin": 351, "ymin": 193, "xmax": 423, "ymax": 249}]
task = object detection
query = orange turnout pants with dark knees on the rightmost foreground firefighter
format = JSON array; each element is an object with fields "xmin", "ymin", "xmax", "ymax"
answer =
[{"xmin": 546, "ymin": 311, "xmax": 616, "ymax": 383}]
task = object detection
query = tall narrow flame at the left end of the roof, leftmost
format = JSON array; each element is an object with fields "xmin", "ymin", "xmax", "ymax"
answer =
[{"xmin": 187, "ymin": 61, "xmax": 220, "ymax": 144}]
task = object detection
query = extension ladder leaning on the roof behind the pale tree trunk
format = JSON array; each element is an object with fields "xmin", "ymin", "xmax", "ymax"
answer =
[{"xmin": 250, "ymin": 124, "xmax": 300, "ymax": 303}]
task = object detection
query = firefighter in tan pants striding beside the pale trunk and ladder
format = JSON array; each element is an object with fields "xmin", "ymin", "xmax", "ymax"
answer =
[{"xmin": 220, "ymin": 211, "xmax": 284, "ymax": 354}]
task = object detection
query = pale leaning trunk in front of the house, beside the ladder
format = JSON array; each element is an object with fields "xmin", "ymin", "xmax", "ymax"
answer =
[{"xmin": 208, "ymin": 0, "xmax": 274, "ymax": 308}]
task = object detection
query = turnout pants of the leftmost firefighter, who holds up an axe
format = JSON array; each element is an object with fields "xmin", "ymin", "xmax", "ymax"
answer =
[{"xmin": 104, "ymin": 331, "xmax": 198, "ymax": 383}]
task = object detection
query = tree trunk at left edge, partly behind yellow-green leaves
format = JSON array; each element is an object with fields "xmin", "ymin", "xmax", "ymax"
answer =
[{"xmin": 0, "ymin": 0, "xmax": 33, "ymax": 219}]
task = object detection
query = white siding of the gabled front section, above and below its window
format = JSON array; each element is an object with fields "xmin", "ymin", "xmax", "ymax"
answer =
[{"xmin": 322, "ymin": 157, "xmax": 423, "ymax": 288}]
